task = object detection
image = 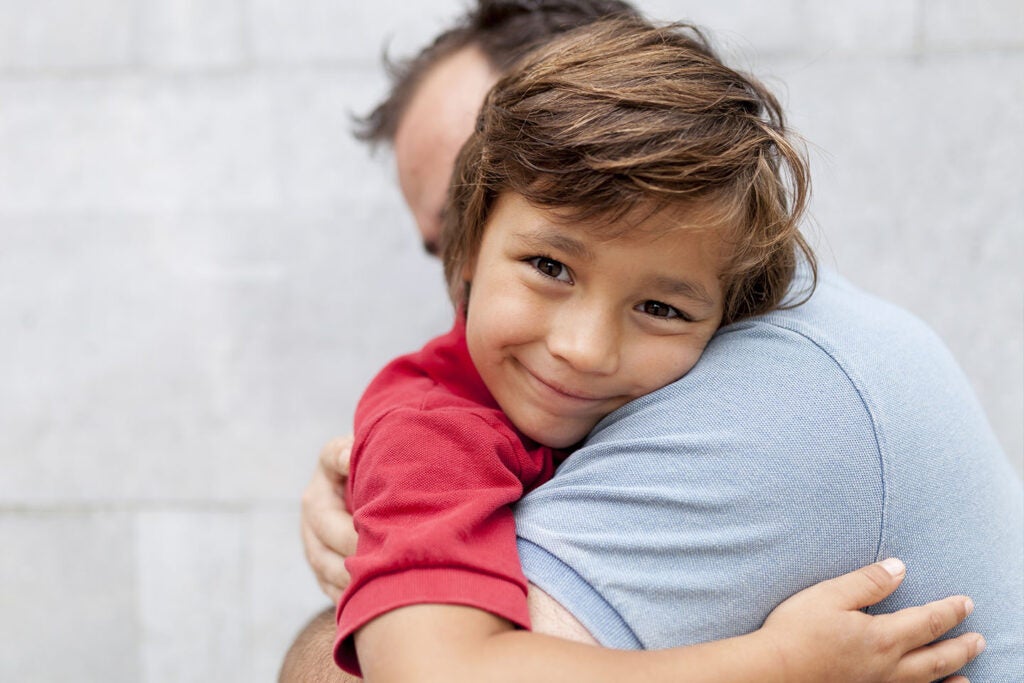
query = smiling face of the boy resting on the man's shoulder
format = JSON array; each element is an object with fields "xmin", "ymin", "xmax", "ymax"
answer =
[{"xmin": 465, "ymin": 194, "xmax": 724, "ymax": 447}]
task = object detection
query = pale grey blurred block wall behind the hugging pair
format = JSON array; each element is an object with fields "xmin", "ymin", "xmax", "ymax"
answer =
[{"xmin": 0, "ymin": 0, "xmax": 1024, "ymax": 683}]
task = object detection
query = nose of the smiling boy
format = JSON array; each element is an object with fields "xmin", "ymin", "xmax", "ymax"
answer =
[{"xmin": 547, "ymin": 307, "xmax": 620, "ymax": 375}]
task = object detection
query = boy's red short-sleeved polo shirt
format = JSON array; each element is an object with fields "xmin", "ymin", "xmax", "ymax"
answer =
[{"xmin": 334, "ymin": 315, "xmax": 556, "ymax": 675}]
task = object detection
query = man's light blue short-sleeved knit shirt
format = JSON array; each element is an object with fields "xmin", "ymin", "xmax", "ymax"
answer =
[{"xmin": 516, "ymin": 272, "xmax": 1024, "ymax": 683}]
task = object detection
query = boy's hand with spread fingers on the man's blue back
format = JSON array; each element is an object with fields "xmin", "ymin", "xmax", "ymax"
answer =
[{"xmin": 762, "ymin": 558, "xmax": 985, "ymax": 683}]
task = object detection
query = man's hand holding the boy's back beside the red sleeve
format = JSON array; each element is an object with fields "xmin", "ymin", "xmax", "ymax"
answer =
[{"xmin": 301, "ymin": 435, "xmax": 357, "ymax": 602}]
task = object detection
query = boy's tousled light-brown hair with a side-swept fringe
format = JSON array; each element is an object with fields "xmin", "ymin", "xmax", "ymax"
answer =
[{"xmin": 441, "ymin": 18, "xmax": 817, "ymax": 325}]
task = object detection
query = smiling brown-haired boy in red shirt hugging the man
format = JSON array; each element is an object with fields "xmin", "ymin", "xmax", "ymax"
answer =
[{"xmin": 336, "ymin": 15, "xmax": 977, "ymax": 681}]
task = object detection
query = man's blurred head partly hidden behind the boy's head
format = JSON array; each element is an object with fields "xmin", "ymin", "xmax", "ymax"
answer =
[{"xmin": 356, "ymin": 0, "xmax": 637, "ymax": 253}]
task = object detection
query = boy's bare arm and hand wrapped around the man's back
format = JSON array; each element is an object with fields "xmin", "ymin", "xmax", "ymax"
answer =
[{"xmin": 355, "ymin": 562, "xmax": 984, "ymax": 683}]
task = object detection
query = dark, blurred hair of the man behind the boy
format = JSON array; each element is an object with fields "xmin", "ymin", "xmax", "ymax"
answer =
[{"xmin": 355, "ymin": 0, "xmax": 639, "ymax": 144}]
